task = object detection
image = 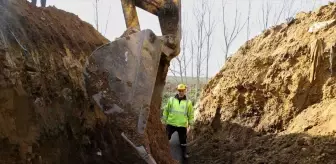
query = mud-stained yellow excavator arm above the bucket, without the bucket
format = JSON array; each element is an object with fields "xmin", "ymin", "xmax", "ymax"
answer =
[{"xmin": 121, "ymin": 0, "xmax": 181, "ymax": 59}]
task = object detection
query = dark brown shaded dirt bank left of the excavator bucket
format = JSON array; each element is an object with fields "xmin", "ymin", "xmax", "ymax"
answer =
[{"xmin": 0, "ymin": 0, "xmax": 172, "ymax": 163}]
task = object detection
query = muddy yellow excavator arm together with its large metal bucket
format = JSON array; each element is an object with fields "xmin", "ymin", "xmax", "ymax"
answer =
[{"xmin": 84, "ymin": 0, "xmax": 181, "ymax": 164}]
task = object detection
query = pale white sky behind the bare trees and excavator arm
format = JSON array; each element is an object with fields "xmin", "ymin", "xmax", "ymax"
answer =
[{"xmin": 27, "ymin": 0, "xmax": 335, "ymax": 77}]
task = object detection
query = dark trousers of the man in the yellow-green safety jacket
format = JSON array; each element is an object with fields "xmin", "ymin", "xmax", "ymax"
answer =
[{"xmin": 166, "ymin": 125, "xmax": 187, "ymax": 158}]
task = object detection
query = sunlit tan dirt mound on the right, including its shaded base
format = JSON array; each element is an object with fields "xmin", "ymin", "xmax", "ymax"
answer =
[{"xmin": 192, "ymin": 3, "xmax": 336, "ymax": 163}]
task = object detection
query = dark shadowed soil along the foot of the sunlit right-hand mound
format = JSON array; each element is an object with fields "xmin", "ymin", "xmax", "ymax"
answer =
[{"xmin": 189, "ymin": 122, "xmax": 336, "ymax": 164}]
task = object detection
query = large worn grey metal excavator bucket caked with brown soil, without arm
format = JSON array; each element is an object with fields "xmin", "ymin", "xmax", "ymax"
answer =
[{"xmin": 84, "ymin": 30, "xmax": 162, "ymax": 163}]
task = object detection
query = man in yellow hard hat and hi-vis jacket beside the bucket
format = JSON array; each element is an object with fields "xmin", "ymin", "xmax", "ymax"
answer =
[{"xmin": 161, "ymin": 84, "xmax": 194, "ymax": 159}]
